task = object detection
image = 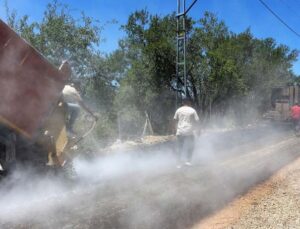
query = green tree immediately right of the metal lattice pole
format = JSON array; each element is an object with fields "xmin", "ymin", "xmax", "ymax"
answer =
[{"xmin": 188, "ymin": 12, "xmax": 297, "ymax": 121}]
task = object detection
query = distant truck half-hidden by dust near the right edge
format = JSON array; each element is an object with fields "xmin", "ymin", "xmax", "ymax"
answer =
[{"xmin": 264, "ymin": 83, "xmax": 300, "ymax": 121}]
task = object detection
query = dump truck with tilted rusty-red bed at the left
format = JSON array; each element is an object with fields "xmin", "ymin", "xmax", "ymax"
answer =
[{"xmin": 0, "ymin": 20, "xmax": 78, "ymax": 172}]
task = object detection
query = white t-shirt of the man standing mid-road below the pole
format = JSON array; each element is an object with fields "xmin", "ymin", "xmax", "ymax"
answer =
[{"xmin": 174, "ymin": 106, "xmax": 199, "ymax": 136}]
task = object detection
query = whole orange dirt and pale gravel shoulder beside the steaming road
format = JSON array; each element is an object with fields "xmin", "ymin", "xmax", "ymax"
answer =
[{"xmin": 193, "ymin": 146, "xmax": 300, "ymax": 229}]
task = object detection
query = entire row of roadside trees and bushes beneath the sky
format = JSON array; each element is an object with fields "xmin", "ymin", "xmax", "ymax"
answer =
[{"xmin": 6, "ymin": 0, "xmax": 298, "ymax": 141}]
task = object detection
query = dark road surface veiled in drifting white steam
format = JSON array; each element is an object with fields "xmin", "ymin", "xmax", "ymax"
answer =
[{"xmin": 0, "ymin": 124, "xmax": 300, "ymax": 229}]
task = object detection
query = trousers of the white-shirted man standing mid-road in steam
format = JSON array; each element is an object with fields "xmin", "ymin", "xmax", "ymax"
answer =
[{"xmin": 177, "ymin": 135, "xmax": 195, "ymax": 162}]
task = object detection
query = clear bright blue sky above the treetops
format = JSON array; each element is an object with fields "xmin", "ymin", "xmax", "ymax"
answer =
[{"xmin": 0, "ymin": 0, "xmax": 300, "ymax": 75}]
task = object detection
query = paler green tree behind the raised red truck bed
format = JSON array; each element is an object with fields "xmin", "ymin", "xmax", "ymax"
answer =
[{"xmin": 6, "ymin": 0, "xmax": 115, "ymax": 140}]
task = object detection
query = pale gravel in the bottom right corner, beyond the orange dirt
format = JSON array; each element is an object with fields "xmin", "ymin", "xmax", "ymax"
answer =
[{"xmin": 227, "ymin": 154, "xmax": 300, "ymax": 229}]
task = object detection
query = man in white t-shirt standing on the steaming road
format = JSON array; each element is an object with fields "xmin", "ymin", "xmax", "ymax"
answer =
[{"xmin": 174, "ymin": 99, "xmax": 199, "ymax": 168}]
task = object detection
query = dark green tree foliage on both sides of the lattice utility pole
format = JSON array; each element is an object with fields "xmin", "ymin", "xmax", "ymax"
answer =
[{"xmin": 116, "ymin": 10, "xmax": 298, "ymax": 131}]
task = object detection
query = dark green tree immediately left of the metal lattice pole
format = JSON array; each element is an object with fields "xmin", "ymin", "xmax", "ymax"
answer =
[{"xmin": 116, "ymin": 10, "xmax": 176, "ymax": 136}]
